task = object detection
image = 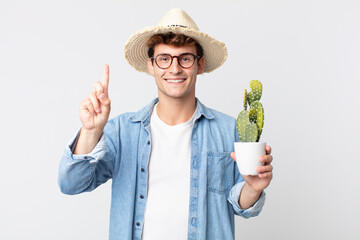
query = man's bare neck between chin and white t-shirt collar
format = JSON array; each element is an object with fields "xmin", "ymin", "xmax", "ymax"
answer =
[{"xmin": 156, "ymin": 96, "xmax": 196, "ymax": 126}]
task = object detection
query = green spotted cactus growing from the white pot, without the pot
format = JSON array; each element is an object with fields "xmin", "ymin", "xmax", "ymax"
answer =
[{"xmin": 236, "ymin": 80, "xmax": 264, "ymax": 142}]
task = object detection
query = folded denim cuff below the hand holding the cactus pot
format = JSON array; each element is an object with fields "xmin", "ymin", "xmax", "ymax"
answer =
[{"xmin": 228, "ymin": 181, "xmax": 266, "ymax": 218}]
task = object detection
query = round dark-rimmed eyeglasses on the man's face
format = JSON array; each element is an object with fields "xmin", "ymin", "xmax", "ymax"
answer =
[{"xmin": 151, "ymin": 53, "xmax": 200, "ymax": 69}]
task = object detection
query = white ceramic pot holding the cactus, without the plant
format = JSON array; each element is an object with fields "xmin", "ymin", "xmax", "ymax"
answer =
[{"xmin": 234, "ymin": 142, "xmax": 266, "ymax": 176}]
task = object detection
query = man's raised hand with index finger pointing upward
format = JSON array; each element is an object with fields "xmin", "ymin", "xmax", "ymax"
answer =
[{"xmin": 80, "ymin": 64, "xmax": 111, "ymax": 135}]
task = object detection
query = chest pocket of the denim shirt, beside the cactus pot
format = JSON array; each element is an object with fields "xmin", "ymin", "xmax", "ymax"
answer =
[{"xmin": 207, "ymin": 151, "xmax": 234, "ymax": 194}]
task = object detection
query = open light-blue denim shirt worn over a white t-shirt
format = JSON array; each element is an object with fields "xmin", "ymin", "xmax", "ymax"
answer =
[{"xmin": 59, "ymin": 98, "xmax": 265, "ymax": 240}]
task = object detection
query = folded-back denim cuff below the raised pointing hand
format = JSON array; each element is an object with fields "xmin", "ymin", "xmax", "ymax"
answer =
[{"xmin": 66, "ymin": 130, "xmax": 107, "ymax": 164}]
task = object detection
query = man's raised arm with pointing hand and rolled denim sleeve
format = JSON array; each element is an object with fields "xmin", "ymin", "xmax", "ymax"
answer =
[{"xmin": 58, "ymin": 65, "xmax": 115, "ymax": 194}]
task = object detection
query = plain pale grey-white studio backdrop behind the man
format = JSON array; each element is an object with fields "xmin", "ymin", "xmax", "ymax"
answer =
[{"xmin": 0, "ymin": 0, "xmax": 360, "ymax": 240}]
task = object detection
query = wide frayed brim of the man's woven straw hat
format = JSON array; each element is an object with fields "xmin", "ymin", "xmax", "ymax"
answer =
[{"xmin": 124, "ymin": 26, "xmax": 227, "ymax": 74}]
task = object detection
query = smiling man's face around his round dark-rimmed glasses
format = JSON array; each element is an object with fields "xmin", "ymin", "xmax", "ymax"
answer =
[{"xmin": 148, "ymin": 44, "xmax": 205, "ymax": 99}]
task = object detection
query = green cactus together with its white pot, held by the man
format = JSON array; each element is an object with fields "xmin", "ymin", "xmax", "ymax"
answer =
[{"xmin": 234, "ymin": 80, "xmax": 266, "ymax": 175}]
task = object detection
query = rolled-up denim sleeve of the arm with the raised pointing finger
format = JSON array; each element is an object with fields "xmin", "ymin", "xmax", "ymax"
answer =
[{"xmin": 58, "ymin": 121, "xmax": 118, "ymax": 195}]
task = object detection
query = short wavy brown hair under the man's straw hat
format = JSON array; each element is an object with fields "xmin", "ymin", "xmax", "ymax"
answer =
[{"xmin": 147, "ymin": 32, "xmax": 204, "ymax": 59}]
